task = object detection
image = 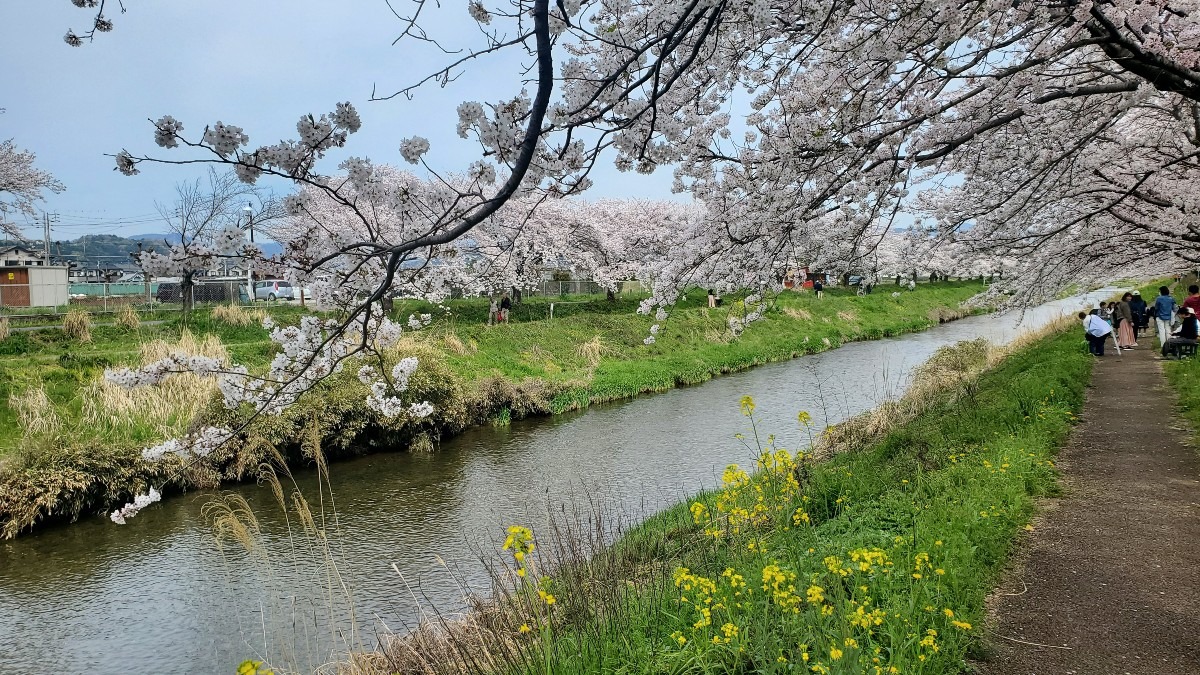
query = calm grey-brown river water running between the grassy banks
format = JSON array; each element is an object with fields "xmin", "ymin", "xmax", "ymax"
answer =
[{"xmin": 0, "ymin": 289, "xmax": 1111, "ymax": 674}]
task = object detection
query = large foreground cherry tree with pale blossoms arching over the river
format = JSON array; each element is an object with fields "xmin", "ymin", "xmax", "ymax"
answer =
[{"xmin": 51, "ymin": 0, "xmax": 1200, "ymax": 514}]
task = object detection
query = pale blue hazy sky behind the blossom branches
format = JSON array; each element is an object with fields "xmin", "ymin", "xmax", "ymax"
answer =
[{"xmin": 0, "ymin": 0, "xmax": 679, "ymax": 239}]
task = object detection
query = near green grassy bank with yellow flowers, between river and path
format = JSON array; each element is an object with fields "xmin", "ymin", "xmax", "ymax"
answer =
[{"xmin": 354, "ymin": 327, "xmax": 1092, "ymax": 675}]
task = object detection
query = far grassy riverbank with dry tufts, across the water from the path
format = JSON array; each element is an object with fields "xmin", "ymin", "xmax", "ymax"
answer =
[{"xmin": 0, "ymin": 283, "xmax": 980, "ymax": 537}]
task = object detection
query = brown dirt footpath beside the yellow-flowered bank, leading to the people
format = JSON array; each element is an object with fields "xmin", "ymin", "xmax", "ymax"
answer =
[{"xmin": 976, "ymin": 336, "xmax": 1200, "ymax": 675}]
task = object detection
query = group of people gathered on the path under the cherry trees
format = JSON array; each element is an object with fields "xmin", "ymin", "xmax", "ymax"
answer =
[{"xmin": 1079, "ymin": 283, "xmax": 1200, "ymax": 357}]
